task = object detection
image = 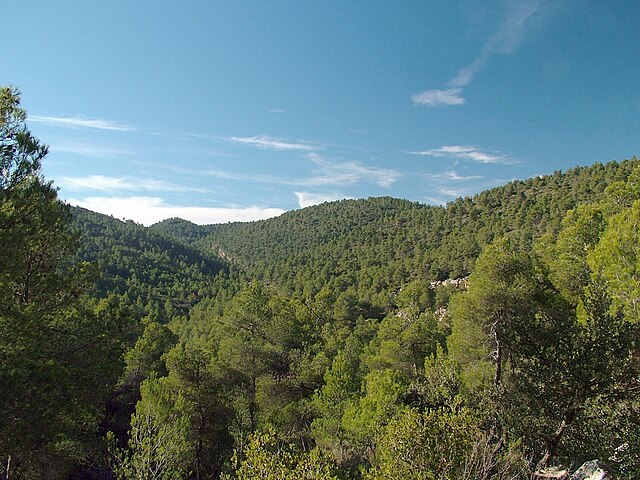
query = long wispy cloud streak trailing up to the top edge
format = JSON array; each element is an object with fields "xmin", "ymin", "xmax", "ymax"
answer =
[{"xmin": 411, "ymin": 0, "xmax": 543, "ymax": 107}]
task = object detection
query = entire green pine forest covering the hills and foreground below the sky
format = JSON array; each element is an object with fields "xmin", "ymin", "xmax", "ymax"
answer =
[{"xmin": 0, "ymin": 88, "xmax": 640, "ymax": 480}]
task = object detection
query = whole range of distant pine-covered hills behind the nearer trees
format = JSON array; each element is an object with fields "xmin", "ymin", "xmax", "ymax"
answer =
[{"xmin": 73, "ymin": 157, "xmax": 640, "ymax": 317}]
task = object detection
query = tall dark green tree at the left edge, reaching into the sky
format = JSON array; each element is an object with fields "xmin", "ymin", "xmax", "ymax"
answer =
[{"xmin": 0, "ymin": 88, "xmax": 128, "ymax": 478}]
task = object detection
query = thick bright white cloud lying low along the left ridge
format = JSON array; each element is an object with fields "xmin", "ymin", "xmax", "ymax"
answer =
[{"xmin": 67, "ymin": 196, "xmax": 285, "ymax": 226}]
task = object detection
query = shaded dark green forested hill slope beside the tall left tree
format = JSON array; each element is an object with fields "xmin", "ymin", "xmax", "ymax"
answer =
[{"xmin": 72, "ymin": 207, "xmax": 228, "ymax": 320}]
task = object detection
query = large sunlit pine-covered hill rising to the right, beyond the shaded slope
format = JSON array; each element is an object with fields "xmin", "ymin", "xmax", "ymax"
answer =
[{"xmin": 150, "ymin": 157, "xmax": 638, "ymax": 297}]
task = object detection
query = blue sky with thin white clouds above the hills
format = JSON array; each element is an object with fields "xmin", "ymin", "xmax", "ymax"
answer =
[{"xmin": 6, "ymin": 0, "xmax": 640, "ymax": 225}]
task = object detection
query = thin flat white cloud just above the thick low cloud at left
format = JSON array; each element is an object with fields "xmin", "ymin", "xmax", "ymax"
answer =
[{"xmin": 57, "ymin": 175, "xmax": 208, "ymax": 193}]
